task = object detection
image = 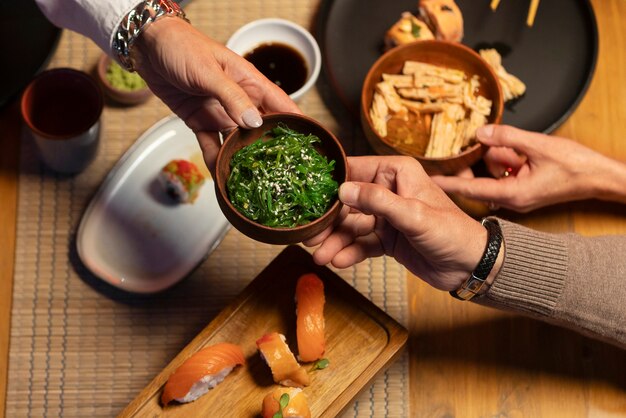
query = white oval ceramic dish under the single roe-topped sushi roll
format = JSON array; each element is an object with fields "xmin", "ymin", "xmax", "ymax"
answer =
[{"xmin": 76, "ymin": 117, "xmax": 230, "ymax": 293}]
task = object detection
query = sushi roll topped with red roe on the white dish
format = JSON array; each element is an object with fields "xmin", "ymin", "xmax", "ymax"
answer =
[{"xmin": 159, "ymin": 160, "xmax": 204, "ymax": 203}]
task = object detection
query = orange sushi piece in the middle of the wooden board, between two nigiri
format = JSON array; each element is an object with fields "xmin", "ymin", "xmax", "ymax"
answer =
[{"xmin": 256, "ymin": 332, "xmax": 310, "ymax": 387}]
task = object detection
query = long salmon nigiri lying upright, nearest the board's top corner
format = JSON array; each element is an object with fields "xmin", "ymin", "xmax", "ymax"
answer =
[{"xmin": 296, "ymin": 273, "xmax": 326, "ymax": 362}]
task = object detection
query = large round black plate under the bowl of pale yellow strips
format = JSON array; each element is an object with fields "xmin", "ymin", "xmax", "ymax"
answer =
[{"xmin": 315, "ymin": 0, "xmax": 598, "ymax": 133}]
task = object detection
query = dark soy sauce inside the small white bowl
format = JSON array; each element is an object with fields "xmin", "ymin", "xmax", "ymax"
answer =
[{"xmin": 244, "ymin": 42, "xmax": 308, "ymax": 94}]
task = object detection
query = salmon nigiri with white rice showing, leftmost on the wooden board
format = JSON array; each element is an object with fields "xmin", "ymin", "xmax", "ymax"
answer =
[{"xmin": 161, "ymin": 343, "xmax": 245, "ymax": 405}]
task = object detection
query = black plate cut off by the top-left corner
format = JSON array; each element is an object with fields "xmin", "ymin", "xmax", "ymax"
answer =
[{"xmin": 0, "ymin": 0, "xmax": 61, "ymax": 107}]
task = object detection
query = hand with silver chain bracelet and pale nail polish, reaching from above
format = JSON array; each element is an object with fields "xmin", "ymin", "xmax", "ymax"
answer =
[{"xmin": 133, "ymin": 18, "xmax": 301, "ymax": 171}]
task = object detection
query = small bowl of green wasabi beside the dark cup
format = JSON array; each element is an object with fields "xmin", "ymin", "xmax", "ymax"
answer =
[{"xmin": 96, "ymin": 54, "xmax": 152, "ymax": 105}]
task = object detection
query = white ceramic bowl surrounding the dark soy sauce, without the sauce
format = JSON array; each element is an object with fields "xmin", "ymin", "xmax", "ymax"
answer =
[{"xmin": 226, "ymin": 18, "xmax": 322, "ymax": 101}]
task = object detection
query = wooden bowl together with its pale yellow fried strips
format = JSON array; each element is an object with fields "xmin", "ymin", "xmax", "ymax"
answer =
[{"xmin": 361, "ymin": 40, "xmax": 503, "ymax": 174}]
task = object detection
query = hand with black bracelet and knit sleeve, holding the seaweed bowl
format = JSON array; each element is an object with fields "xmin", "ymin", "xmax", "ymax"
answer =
[{"xmin": 304, "ymin": 156, "xmax": 487, "ymax": 290}]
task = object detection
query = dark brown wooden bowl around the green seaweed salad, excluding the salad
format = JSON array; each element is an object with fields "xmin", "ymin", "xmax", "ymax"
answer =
[{"xmin": 215, "ymin": 113, "xmax": 348, "ymax": 244}]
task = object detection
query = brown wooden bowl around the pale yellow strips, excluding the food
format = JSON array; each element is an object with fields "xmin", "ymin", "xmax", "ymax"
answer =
[{"xmin": 361, "ymin": 40, "xmax": 503, "ymax": 174}]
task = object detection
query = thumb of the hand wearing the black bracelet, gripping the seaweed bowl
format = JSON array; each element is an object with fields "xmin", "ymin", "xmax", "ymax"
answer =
[{"xmin": 339, "ymin": 182, "xmax": 419, "ymax": 232}]
